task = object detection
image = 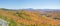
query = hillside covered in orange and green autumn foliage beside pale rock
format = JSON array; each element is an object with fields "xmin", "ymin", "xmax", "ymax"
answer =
[{"xmin": 0, "ymin": 10, "xmax": 60, "ymax": 26}]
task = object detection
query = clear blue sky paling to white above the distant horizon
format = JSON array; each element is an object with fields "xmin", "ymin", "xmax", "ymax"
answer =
[{"xmin": 0, "ymin": 0, "xmax": 60, "ymax": 9}]
